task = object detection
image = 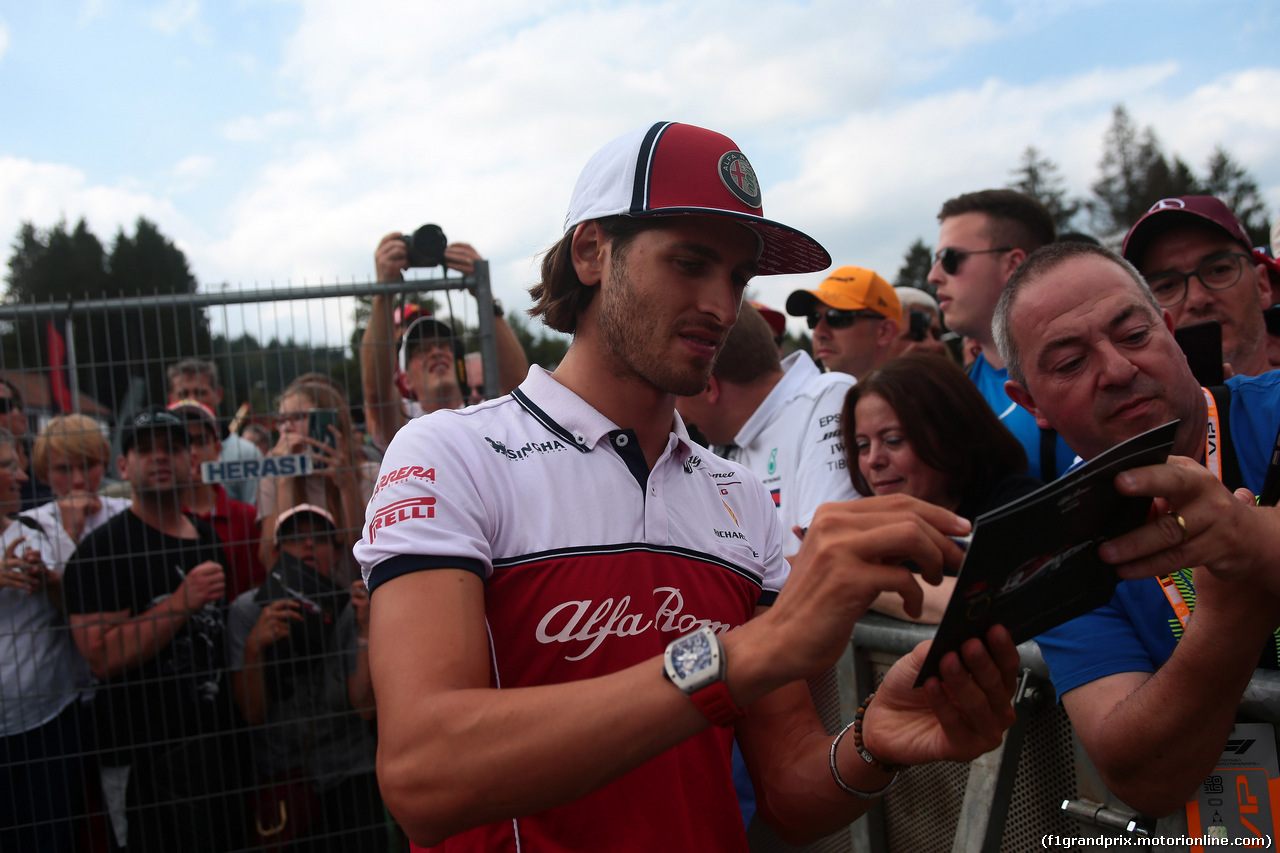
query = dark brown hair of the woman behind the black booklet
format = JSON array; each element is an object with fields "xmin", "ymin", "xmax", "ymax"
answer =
[{"xmin": 841, "ymin": 352, "xmax": 1027, "ymax": 501}]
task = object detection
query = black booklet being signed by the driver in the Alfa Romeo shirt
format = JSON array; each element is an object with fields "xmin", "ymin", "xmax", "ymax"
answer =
[{"xmin": 915, "ymin": 420, "xmax": 1178, "ymax": 686}]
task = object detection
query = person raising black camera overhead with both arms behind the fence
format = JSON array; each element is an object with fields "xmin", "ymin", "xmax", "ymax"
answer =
[{"xmin": 360, "ymin": 229, "xmax": 529, "ymax": 450}]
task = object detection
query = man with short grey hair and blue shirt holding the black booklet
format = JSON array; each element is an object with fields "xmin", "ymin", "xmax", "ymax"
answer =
[{"xmin": 993, "ymin": 243, "xmax": 1280, "ymax": 816}]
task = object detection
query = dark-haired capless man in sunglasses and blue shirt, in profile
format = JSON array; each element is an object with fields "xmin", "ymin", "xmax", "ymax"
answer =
[{"xmin": 929, "ymin": 190, "xmax": 1075, "ymax": 482}]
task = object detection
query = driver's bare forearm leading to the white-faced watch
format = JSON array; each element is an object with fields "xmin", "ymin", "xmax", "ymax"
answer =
[{"xmin": 375, "ymin": 650, "xmax": 708, "ymax": 847}]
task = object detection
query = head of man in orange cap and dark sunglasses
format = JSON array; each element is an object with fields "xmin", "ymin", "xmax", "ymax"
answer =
[{"xmin": 787, "ymin": 266, "xmax": 902, "ymax": 379}]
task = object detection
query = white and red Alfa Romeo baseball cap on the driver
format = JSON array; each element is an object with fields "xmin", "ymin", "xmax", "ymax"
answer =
[{"xmin": 564, "ymin": 122, "xmax": 831, "ymax": 275}]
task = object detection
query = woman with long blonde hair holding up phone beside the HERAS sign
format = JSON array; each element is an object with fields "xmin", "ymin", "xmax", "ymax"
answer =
[{"xmin": 257, "ymin": 378, "xmax": 378, "ymax": 585}]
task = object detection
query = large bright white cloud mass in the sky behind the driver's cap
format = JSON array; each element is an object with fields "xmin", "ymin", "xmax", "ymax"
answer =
[{"xmin": 10, "ymin": 0, "xmax": 1280, "ymax": 325}]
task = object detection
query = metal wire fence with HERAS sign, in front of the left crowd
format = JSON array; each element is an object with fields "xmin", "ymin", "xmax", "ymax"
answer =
[{"xmin": 0, "ymin": 263, "xmax": 498, "ymax": 852}]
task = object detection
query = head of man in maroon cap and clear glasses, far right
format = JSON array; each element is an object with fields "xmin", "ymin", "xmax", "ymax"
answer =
[{"xmin": 1124, "ymin": 196, "xmax": 1271, "ymax": 377}]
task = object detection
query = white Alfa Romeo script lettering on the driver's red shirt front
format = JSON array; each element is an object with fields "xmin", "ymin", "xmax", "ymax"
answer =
[{"xmin": 534, "ymin": 587, "xmax": 732, "ymax": 661}]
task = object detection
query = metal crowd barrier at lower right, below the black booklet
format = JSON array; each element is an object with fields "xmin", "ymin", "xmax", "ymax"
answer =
[{"xmin": 749, "ymin": 613, "xmax": 1280, "ymax": 853}]
